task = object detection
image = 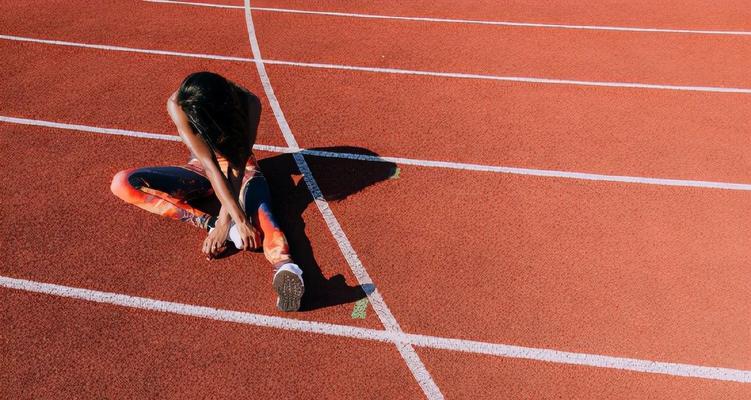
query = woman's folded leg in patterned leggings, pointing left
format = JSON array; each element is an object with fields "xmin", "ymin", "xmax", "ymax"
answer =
[{"xmin": 110, "ymin": 166, "xmax": 213, "ymax": 228}]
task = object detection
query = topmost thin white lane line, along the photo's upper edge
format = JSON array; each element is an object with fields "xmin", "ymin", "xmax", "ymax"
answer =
[{"xmin": 144, "ymin": 0, "xmax": 751, "ymax": 36}]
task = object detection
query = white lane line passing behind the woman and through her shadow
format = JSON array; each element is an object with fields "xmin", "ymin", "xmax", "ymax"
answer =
[{"xmin": 0, "ymin": 115, "xmax": 751, "ymax": 191}]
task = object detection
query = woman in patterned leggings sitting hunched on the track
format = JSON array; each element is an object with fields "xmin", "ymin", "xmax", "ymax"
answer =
[{"xmin": 111, "ymin": 72, "xmax": 304, "ymax": 311}]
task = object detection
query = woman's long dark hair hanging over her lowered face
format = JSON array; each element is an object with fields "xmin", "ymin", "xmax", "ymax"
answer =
[{"xmin": 177, "ymin": 71, "xmax": 257, "ymax": 167}]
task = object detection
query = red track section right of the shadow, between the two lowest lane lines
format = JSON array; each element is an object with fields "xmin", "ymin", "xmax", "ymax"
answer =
[{"xmin": 324, "ymin": 165, "xmax": 751, "ymax": 369}]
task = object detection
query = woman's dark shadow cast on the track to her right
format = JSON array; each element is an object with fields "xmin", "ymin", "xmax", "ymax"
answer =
[{"xmin": 191, "ymin": 146, "xmax": 398, "ymax": 311}]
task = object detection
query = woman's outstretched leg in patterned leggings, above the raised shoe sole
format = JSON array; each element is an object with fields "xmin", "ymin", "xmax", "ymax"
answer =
[{"xmin": 240, "ymin": 170, "xmax": 292, "ymax": 267}]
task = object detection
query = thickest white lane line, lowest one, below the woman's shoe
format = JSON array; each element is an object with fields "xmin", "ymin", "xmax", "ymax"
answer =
[{"xmin": 0, "ymin": 276, "xmax": 751, "ymax": 383}]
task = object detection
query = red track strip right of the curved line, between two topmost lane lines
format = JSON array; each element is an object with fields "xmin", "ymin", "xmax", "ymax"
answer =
[{"xmin": 250, "ymin": 6, "xmax": 751, "ymax": 87}]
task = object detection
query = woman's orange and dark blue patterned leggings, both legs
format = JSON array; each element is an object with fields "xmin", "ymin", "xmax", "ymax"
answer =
[{"xmin": 111, "ymin": 156, "xmax": 292, "ymax": 266}]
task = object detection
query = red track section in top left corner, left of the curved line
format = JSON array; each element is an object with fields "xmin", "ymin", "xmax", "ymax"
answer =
[{"xmin": 0, "ymin": 0, "xmax": 250, "ymax": 57}]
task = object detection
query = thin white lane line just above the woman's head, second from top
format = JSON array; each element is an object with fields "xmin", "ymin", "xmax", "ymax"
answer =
[{"xmin": 0, "ymin": 35, "xmax": 751, "ymax": 94}]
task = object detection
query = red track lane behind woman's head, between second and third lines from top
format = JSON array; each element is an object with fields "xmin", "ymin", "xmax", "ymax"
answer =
[{"xmin": 5, "ymin": 41, "xmax": 751, "ymax": 182}]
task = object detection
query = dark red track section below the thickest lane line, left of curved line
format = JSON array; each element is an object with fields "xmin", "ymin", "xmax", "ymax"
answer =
[{"xmin": 0, "ymin": 289, "xmax": 421, "ymax": 399}]
